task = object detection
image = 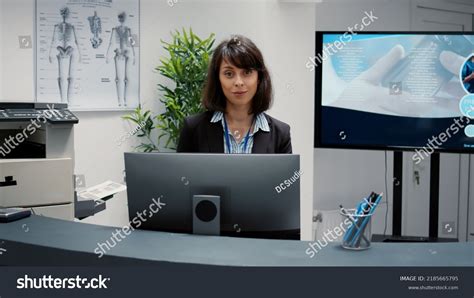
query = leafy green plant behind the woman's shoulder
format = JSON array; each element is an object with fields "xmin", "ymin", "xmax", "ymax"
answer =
[{"xmin": 122, "ymin": 29, "xmax": 215, "ymax": 152}]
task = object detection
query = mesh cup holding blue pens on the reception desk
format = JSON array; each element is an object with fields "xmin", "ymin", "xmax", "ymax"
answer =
[{"xmin": 341, "ymin": 209, "xmax": 372, "ymax": 250}]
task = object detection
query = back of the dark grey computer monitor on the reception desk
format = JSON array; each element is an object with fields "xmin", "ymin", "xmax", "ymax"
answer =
[{"xmin": 125, "ymin": 153, "xmax": 301, "ymax": 239}]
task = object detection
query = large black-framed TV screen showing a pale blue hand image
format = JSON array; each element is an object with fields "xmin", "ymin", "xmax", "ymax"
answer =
[{"xmin": 314, "ymin": 32, "xmax": 474, "ymax": 153}]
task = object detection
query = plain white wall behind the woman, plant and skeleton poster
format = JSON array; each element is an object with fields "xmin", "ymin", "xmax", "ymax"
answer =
[{"xmin": 0, "ymin": 0, "xmax": 315, "ymax": 239}]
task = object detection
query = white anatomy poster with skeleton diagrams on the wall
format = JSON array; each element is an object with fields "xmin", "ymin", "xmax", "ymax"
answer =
[{"xmin": 36, "ymin": 0, "xmax": 139, "ymax": 110}]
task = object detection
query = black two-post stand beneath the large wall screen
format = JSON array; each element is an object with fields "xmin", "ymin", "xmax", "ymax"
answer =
[{"xmin": 372, "ymin": 151, "xmax": 458, "ymax": 242}]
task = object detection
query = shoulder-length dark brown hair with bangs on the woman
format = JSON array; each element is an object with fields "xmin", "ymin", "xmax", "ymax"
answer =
[{"xmin": 202, "ymin": 35, "xmax": 273, "ymax": 114}]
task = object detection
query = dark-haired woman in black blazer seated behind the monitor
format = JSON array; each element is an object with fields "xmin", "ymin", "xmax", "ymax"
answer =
[{"xmin": 177, "ymin": 35, "xmax": 292, "ymax": 153}]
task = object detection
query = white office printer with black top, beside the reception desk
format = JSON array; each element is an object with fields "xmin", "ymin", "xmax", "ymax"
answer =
[{"xmin": 0, "ymin": 102, "xmax": 109, "ymax": 220}]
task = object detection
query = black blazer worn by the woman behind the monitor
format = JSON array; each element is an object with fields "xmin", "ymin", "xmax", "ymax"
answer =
[{"xmin": 177, "ymin": 111, "xmax": 292, "ymax": 153}]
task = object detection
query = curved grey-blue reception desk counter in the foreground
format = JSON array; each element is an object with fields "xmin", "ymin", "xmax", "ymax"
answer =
[{"xmin": 0, "ymin": 216, "xmax": 474, "ymax": 267}]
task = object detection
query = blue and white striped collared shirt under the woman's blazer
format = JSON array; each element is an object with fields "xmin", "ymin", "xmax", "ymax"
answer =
[{"xmin": 211, "ymin": 112, "xmax": 270, "ymax": 154}]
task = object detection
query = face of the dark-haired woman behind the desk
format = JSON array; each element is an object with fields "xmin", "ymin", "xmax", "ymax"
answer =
[{"xmin": 219, "ymin": 60, "xmax": 258, "ymax": 108}]
